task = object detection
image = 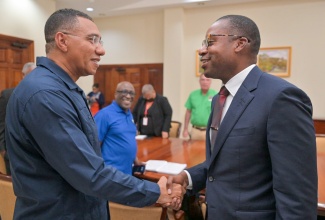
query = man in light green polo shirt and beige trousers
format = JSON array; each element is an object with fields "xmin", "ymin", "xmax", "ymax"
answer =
[{"xmin": 183, "ymin": 74, "xmax": 217, "ymax": 140}]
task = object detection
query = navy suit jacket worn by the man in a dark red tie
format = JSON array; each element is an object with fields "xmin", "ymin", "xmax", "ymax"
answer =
[{"xmin": 188, "ymin": 67, "xmax": 317, "ymax": 220}]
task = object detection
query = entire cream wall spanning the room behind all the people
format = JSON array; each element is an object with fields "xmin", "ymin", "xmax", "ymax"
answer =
[{"xmin": 0, "ymin": 0, "xmax": 325, "ymax": 121}]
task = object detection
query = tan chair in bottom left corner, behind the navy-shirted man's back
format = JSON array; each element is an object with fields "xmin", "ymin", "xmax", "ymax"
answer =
[{"xmin": 0, "ymin": 174, "xmax": 16, "ymax": 220}]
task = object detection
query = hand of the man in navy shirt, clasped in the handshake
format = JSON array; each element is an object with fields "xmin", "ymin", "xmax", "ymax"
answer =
[{"xmin": 157, "ymin": 176, "xmax": 185, "ymax": 210}]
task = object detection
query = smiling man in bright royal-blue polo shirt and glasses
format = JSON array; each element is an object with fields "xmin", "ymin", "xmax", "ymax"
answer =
[{"xmin": 95, "ymin": 82, "xmax": 141, "ymax": 174}]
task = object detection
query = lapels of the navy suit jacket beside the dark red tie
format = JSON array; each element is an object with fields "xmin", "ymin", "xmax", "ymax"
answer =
[{"xmin": 207, "ymin": 67, "xmax": 262, "ymax": 165}]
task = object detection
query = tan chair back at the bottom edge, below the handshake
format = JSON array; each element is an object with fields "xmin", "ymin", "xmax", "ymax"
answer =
[{"xmin": 108, "ymin": 202, "xmax": 166, "ymax": 220}]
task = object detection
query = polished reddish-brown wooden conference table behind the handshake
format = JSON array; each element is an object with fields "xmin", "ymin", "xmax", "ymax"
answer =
[{"xmin": 137, "ymin": 137, "xmax": 325, "ymax": 216}]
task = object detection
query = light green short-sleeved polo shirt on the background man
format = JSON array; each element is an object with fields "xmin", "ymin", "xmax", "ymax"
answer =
[{"xmin": 185, "ymin": 89, "xmax": 217, "ymax": 127}]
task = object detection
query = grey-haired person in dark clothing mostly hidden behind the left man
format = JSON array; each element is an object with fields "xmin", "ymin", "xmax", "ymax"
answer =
[{"xmin": 0, "ymin": 62, "xmax": 36, "ymax": 175}]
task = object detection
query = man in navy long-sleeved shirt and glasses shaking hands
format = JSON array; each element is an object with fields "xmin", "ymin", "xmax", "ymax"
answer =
[{"xmin": 6, "ymin": 9, "xmax": 183, "ymax": 220}]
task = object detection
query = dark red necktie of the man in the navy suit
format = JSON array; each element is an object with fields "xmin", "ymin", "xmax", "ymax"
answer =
[{"xmin": 210, "ymin": 86, "xmax": 229, "ymax": 152}]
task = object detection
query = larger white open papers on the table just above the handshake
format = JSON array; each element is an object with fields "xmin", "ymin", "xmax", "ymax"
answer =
[{"xmin": 146, "ymin": 160, "xmax": 186, "ymax": 175}]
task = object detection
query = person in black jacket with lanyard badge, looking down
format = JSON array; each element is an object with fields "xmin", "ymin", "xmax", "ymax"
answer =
[{"xmin": 132, "ymin": 84, "xmax": 173, "ymax": 138}]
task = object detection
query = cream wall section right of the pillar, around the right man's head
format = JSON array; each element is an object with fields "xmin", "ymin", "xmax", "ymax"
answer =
[{"xmin": 184, "ymin": 1, "xmax": 325, "ymax": 119}]
